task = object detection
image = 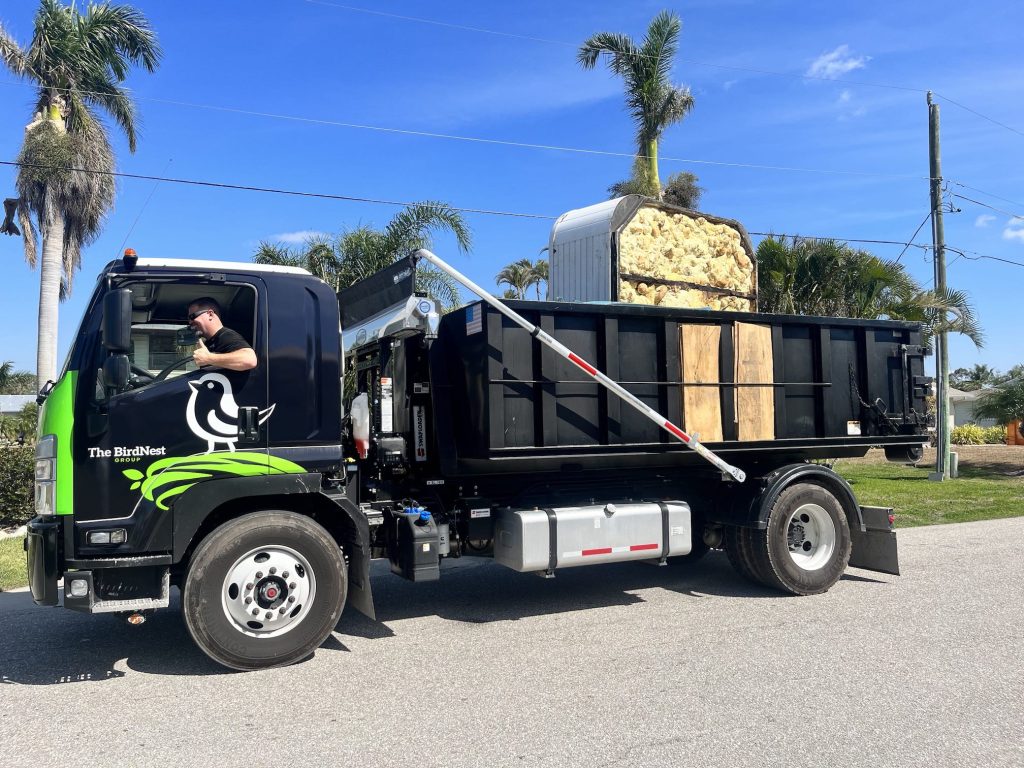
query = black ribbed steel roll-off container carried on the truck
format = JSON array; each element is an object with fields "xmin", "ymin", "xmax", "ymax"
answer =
[{"xmin": 429, "ymin": 301, "xmax": 927, "ymax": 475}]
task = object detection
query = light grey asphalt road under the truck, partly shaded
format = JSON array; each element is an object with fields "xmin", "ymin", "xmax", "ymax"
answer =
[{"xmin": 0, "ymin": 518, "xmax": 1024, "ymax": 768}]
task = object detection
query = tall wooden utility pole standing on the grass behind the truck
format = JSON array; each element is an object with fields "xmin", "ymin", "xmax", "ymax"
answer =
[{"xmin": 928, "ymin": 91, "xmax": 949, "ymax": 480}]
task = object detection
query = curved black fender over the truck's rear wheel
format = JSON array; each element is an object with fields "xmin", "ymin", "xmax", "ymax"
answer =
[{"xmin": 716, "ymin": 464, "xmax": 865, "ymax": 532}]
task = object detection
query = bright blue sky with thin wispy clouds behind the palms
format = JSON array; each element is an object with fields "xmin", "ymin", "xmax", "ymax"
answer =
[{"xmin": 0, "ymin": 0, "xmax": 1024, "ymax": 370}]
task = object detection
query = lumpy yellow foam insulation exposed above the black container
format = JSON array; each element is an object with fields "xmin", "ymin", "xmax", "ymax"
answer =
[{"xmin": 618, "ymin": 207, "xmax": 755, "ymax": 311}]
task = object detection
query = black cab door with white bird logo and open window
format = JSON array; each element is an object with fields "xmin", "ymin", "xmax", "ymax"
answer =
[{"xmin": 75, "ymin": 273, "xmax": 273, "ymax": 557}]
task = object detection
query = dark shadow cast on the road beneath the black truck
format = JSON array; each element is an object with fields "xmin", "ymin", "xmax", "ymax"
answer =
[{"xmin": 0, "ymin": 552, "xmax": 884, "ymax": 686}]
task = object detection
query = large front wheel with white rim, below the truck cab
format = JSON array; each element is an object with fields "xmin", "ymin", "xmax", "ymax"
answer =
[{"xmin": 182, "ymin": 511, "xmax": 348, "ymax": 670}]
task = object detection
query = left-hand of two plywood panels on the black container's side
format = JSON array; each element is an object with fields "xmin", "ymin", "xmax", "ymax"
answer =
[{"xmin": 679, "ymin": 325, "xmax": 722, "ymax": 442}]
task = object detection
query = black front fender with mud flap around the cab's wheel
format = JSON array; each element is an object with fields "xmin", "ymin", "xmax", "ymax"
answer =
[{"xmin": 172, "ymin": 472, "xmax": 376, "ymax": 618}]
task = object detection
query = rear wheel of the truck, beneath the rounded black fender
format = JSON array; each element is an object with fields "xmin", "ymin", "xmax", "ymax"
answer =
[{"xmin": 749, "ymin": 482, "xmax": 851, "ymax": 595}]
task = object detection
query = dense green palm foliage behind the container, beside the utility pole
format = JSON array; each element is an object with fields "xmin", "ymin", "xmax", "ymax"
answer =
[{"xmin": 757, "ymin": 238, "xmax": 984, "ymax": 347}]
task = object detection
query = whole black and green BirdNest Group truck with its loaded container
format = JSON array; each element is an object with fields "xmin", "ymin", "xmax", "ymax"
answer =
[{"xmin": 26, "ymin": 251, "xmax": 930, "ymax": 670}]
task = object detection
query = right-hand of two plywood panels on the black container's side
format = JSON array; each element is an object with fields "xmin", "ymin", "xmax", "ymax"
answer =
[{"xmin": 735, "ymin": 323, "xmax": 775, "ymax": 440}]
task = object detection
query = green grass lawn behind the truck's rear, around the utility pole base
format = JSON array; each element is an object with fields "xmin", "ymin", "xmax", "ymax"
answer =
[{"xmin": 835, "ymin": 461, "xmax": 1024, "ymax": 528}]
